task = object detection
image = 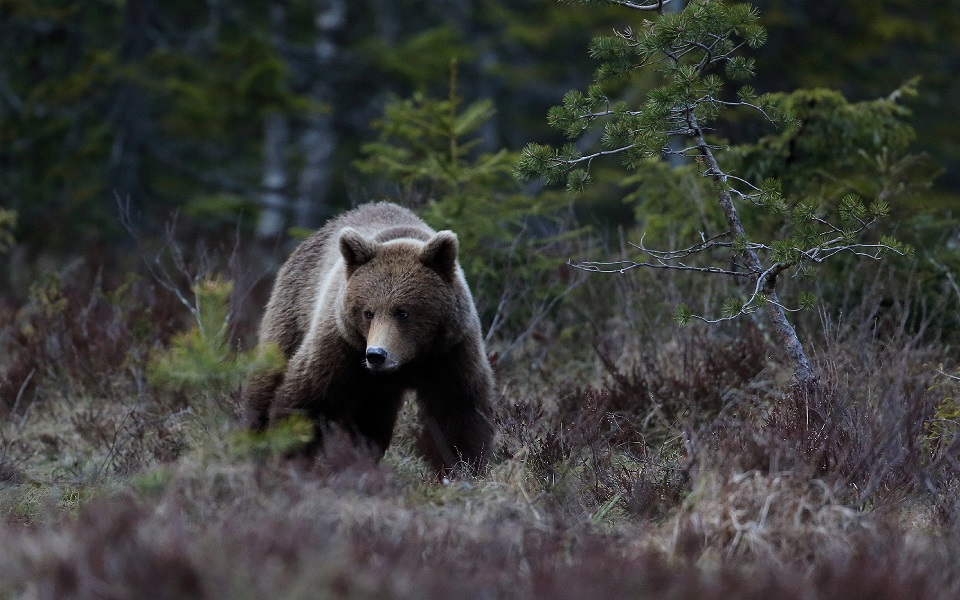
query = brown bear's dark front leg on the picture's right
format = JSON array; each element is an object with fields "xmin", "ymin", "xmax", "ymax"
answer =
[{"xmin": 416, "ymin": 341, "xmax": 494, "ymax": 474}]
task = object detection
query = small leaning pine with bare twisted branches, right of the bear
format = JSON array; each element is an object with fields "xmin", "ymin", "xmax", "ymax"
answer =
[{"xmin": 516, "ymin": 0, "xmax": 912, "ymax": 390}]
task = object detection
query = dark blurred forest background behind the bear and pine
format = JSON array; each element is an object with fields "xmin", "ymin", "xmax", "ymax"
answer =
[{"xmin": 0, "ymin": 0, "xmax": 960, "ymax": 268}]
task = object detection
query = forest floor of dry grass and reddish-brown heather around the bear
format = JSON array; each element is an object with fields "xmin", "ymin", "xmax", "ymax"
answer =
[{"xmin": 0, "ymin": 255, "xmax": 960, "ymax": 600}]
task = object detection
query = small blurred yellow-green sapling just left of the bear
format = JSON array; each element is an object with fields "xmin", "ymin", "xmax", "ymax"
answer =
[{"xmin": 147, "ymin": 277, "xmax": 285, "ymax": 395}]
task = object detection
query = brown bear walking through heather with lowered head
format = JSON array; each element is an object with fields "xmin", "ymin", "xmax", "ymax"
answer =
[{"xmin": 245, "ymin": 202, "xmax": 494, "ymax": 473}]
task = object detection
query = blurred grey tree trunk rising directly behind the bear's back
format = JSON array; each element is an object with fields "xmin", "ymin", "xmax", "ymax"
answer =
[{"xmin": 295, "ymin": 0, "xmax": 347, "ymax": 227}]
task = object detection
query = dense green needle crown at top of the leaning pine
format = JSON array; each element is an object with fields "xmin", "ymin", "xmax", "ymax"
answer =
[{"xmin": 516, "ymin": 0, "xmax": 765, "ymax": 181}]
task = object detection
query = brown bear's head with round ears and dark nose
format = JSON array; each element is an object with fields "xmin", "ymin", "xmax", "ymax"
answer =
[{"xmin": 337, "ymin": 227, "xmax": 472, "ymax": 372}]
